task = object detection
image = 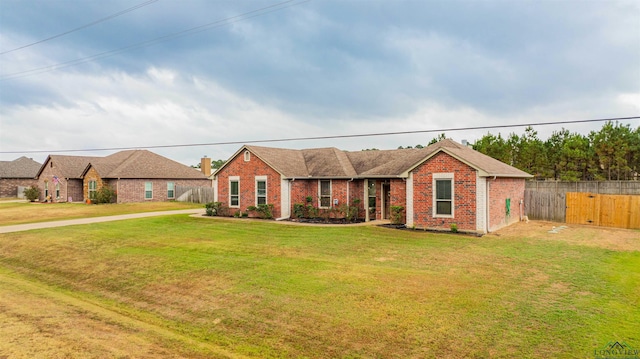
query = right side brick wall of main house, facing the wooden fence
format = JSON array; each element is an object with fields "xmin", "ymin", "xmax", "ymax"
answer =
[{"xmin": 487, "ymin": 178, "xmax": 525, "ymax": 232}]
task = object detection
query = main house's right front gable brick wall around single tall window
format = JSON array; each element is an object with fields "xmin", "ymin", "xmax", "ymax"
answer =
[{"xmin": 413, "ymin": 152, "xmax": 476, "ymax": 231}]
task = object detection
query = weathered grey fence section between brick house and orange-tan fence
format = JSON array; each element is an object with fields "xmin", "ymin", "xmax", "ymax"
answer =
[{"xmin": 524, "ymin": 189, "xmax": 566, "ymax": 222}]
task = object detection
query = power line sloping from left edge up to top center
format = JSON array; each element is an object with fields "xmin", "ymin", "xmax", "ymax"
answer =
[{"xmin": 0, "ymin": 0, "xmax": 311, "ymax": 81}]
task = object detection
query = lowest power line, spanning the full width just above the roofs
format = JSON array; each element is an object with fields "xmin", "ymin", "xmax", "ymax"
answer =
[{"xmin": 0, "ymin": 116, "xmax": 640, "ymax": 154}]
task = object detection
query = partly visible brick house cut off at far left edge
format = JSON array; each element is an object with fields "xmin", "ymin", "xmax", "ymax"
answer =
[{"xmin": 0, "ymin": 156, "xmax": 41, "ymax": 198}]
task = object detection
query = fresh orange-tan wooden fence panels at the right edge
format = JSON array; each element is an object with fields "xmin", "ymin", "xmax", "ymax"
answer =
[{"xmin": 565, "ymin": 192, "xmax": 640, "ymax": 229}]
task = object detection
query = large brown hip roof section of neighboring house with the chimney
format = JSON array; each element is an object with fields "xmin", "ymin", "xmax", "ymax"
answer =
[{"xmin": 83, "ymin": 150, "xmax": 207, "ymax": 179}]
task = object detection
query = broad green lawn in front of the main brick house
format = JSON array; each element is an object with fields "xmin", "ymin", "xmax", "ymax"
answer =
[{"xmin": 0, "ymin": 216, "xmax": 640, "ymax": 358}]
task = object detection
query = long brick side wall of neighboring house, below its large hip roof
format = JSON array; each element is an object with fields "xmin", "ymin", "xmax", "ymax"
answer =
[{"xmin": 115, "ymin": 178, "xmax": 211, "ymax": 203}]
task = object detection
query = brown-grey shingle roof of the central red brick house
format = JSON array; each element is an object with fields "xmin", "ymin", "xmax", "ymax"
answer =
[{"xmin": 228, "ymin": 139, "xmax": 532, "ymax": 178}]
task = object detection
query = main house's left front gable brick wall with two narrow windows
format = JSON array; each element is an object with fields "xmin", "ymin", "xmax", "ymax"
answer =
[{"xmin": 217, "ymin": 153, "xmax": 282, "ymax": 218}]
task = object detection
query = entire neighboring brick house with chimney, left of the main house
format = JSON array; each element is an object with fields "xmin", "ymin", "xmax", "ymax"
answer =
[{"xmin": 38, "ymin": 150, "xmax": 211, "ymax": 203}]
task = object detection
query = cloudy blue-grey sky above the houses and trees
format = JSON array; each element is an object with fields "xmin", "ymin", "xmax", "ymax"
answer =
[{"xmin": 0, "ymin": 0, "xmax": 640, "ymax": 165}]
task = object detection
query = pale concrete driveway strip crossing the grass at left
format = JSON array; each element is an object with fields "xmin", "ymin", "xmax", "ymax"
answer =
[{"xmin": 0, "ymin": 208, "xmax": 205, "ymax": 233}]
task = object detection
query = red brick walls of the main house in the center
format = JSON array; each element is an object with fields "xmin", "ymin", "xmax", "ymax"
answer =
[{"xmin": 216, "ymin": 146, "xmax": 525, "ymax": 232}]
